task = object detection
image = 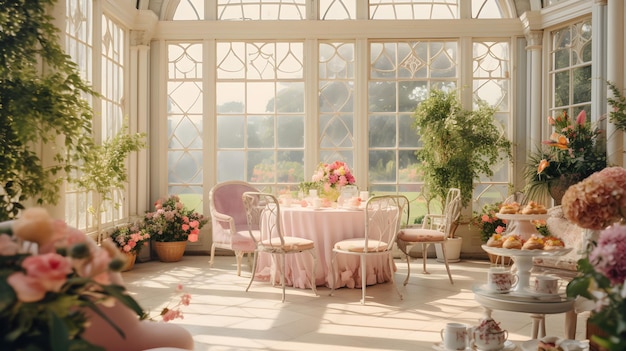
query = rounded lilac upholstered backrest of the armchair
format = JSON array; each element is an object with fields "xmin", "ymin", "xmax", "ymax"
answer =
[{"xmin": 209, "ymin": 180, "xmax": 258, "ymax": 225}]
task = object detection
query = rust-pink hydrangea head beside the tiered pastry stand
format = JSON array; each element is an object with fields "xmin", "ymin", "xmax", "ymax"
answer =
[{"xmin": 562, "ymin": 167, "xmax": 626, "ymax": 230}]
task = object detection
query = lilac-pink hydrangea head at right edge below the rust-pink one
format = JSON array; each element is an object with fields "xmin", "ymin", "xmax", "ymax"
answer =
[{"xmin": 589, "ymin": 224, "xmax": 626, "ymax": 284}]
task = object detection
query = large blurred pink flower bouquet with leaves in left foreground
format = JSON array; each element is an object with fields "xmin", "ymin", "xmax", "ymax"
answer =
[{"xmin": 0, "ymin": 208, "xmax": 144, "ymax": 350}]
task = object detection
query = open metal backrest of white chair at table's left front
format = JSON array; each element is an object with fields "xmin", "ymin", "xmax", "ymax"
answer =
[{"xmin": 241, "ymin": 191, "xmax": 285, "ymax": 249}]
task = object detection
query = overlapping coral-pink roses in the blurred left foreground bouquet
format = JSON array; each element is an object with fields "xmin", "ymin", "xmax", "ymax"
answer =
[{"xmin": 7, "ymin": 253, "xmax": 72, "ymax": 302}]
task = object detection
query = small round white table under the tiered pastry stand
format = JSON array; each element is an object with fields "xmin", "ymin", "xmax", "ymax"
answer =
[{"xmin": 473, "ymin": 286, "xmax": 576, "ymax": 339}]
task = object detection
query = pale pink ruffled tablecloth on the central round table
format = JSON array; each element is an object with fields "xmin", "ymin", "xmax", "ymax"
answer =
[{"xmin": 256, "ymin": 206, "xmax": 392, "ymax": 289}]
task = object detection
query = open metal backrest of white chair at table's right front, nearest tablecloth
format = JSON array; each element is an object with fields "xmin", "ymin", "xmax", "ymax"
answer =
[{"xmin": 365, "ymin": 195, "xmax": 409, "ymax": 251}]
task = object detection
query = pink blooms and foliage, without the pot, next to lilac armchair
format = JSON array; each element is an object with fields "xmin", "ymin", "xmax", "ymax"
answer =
[{"xmin": 144, "ymin": 195, "xmax": 208, "ymax": 242}]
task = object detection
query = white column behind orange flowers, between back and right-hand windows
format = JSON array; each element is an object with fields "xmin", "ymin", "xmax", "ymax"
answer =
[{"xmin": 526, "ymin": 30, "xmax": 543, "ymax": 153}]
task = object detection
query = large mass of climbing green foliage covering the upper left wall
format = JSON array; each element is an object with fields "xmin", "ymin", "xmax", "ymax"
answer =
[{"xmin": 0, "ymin": 0, "xmax": 96, "ymax": 221}]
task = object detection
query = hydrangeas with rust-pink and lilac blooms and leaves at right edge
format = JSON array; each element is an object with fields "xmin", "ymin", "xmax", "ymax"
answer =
[{"xmin": 562, "ymin": 167, "xmax": 626, "ymax": 351}]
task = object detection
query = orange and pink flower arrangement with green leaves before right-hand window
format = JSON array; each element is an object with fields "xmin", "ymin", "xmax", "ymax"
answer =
[{"xmin": 524, "ymin": 110, "xmax": 606, "ymax": 205}]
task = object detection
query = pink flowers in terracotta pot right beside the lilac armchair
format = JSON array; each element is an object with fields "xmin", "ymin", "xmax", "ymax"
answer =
[{"xmin": 144, "ymin": 195, "xmax": 208, "ymax": 262}]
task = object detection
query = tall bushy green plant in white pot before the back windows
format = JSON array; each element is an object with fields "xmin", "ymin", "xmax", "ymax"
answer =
[{"xmin": 413, "ymin": 89, "xmax": 511, "ymax": 257}]
